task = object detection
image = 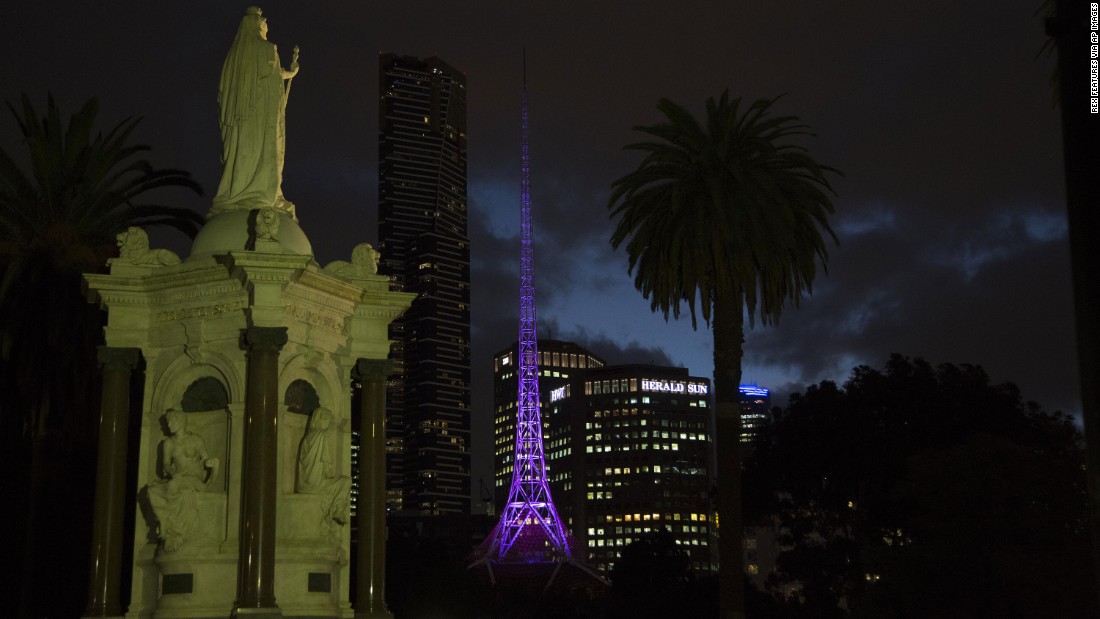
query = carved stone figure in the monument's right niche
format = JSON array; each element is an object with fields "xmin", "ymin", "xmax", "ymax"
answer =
[{"xmin": 298, "ymin": 408, "xmax": 351, "ymax": 527}]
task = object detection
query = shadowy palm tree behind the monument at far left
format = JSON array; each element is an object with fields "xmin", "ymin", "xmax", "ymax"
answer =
[{"xmin": 0, "ymin": 95, "xmax": 202, "ymax": 615}]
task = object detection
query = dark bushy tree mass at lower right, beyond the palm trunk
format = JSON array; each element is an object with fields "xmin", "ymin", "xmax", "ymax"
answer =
[{"xmin": 746, "ymin": 355, "xmax": 1096, "ymax": 618}]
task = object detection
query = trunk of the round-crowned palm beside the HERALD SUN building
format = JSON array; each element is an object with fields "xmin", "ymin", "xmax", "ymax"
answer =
[{"xmin": 714, "ymin": 292, "xmax": 745, "ymax": 619}]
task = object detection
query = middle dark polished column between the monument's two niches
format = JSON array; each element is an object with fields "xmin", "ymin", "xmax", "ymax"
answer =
[{"xmin": 233, "ymin": 327, "xmax": 287, "ymax": 619}]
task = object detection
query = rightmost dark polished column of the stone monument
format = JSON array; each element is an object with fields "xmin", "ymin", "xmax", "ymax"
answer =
[{"xmin": 355, "ymin": 358, "xmax": 393, "ymax": 619}]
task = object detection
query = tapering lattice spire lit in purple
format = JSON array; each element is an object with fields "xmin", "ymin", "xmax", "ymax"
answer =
[{"xmin": 486, "ymin": 63, "xmax": 572, "ymax": 563}]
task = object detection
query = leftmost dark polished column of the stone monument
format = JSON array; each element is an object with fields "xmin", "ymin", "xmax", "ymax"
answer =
[{"xmin": 84, "ymin": 346, "xmax": 141, "ymax": 617}]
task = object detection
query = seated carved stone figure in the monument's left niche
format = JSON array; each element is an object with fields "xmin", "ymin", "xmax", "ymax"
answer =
[{"xmin": 147, "ymin": 411, "xmax": 219, "ymax": 552}]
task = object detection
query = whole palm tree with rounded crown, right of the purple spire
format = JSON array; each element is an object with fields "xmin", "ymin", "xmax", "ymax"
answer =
[{"xmin": 607, "ymin": 90, "xmax": 839, "ymax": 619}]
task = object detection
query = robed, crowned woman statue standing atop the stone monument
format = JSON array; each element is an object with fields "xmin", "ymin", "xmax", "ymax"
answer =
[{"xmin": 207, "ymin": 7, "xmax": 298, "ymax": 221}]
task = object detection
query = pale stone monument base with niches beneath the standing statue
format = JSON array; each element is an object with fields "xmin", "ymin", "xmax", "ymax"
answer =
[{"xmin": 86, "ymin": 212, "xmax": 411, "ymax": 619}]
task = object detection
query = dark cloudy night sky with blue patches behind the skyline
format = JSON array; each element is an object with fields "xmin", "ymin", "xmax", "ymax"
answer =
[{"xmin": 0, "ymin": 0, "xmax": 1080, "ymax": 494}]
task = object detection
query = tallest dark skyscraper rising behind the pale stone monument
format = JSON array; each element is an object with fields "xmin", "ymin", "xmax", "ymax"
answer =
[{"xmin": 378, "ymin": 54, "xmax": 470, "ymax": 515}]
